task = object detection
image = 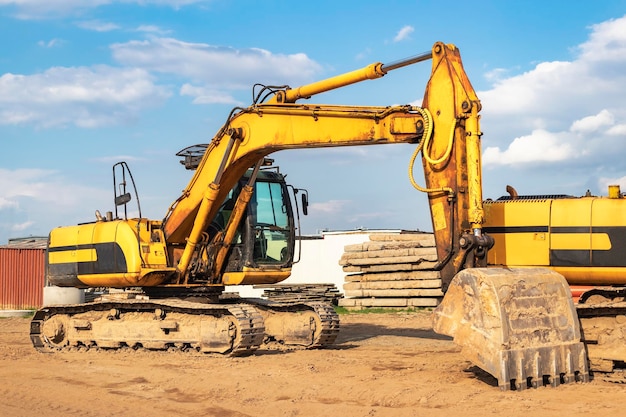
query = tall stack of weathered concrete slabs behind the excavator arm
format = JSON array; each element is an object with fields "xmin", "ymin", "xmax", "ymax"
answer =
[{"xmin": 339, "ymin": 232, "xmax": 443, "ymax": 309}]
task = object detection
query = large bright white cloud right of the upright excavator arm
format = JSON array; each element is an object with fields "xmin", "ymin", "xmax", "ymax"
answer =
[{"xmin": 478, "ymin": 16, "xmax": 626, "ymax": 129}]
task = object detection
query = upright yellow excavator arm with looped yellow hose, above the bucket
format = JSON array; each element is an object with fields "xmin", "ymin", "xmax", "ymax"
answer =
[{"xmin": 414, "ymin": 44, "xmax": 493, "ymax": 292}]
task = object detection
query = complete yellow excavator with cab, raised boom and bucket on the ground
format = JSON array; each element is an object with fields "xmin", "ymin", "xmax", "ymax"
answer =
[{"xmin": 31, "ymin": 42, "xmax": 616, "ymax": 389}]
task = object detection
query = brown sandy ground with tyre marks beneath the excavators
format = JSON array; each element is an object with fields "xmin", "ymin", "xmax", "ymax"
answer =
[{"xmin": 0, "ymin": 313, "xmax": 626, "ymax": 417}]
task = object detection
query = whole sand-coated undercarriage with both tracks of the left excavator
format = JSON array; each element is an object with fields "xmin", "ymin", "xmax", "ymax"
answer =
[{"xmin": 30, "ymin": 299, "xmax": 339, "ymax": 356}]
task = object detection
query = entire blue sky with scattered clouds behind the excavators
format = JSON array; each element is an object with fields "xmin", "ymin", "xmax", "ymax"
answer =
[{"xmin": 0, "ymin": 0, "xmax": 626, "ymax": 243}]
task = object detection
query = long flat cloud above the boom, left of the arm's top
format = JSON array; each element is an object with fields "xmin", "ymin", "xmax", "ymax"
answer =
[{"xmin": 111, "ymin": 38, "xmax": 321, "ymax": 89}]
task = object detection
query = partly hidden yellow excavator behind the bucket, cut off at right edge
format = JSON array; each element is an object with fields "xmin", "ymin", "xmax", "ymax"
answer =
[{"xmin": 483, "ymin": 185, "xmax": 626, "ymax": 382}]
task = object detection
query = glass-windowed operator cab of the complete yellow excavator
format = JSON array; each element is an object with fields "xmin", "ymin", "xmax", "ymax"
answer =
[{"xmin": 176, "ymin": 144, "xmax": 300, "ymax": 285}]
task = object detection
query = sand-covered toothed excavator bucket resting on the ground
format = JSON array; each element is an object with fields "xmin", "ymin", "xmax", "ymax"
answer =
[{"xmin": 433, "ymin": 268, "xmax": 589, "ymax": 390}]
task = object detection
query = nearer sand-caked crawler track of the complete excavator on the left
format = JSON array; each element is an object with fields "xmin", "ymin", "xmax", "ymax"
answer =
[{"xmin": 30, "ymin": 300, "xmax": 265, "ymax": 356}]
